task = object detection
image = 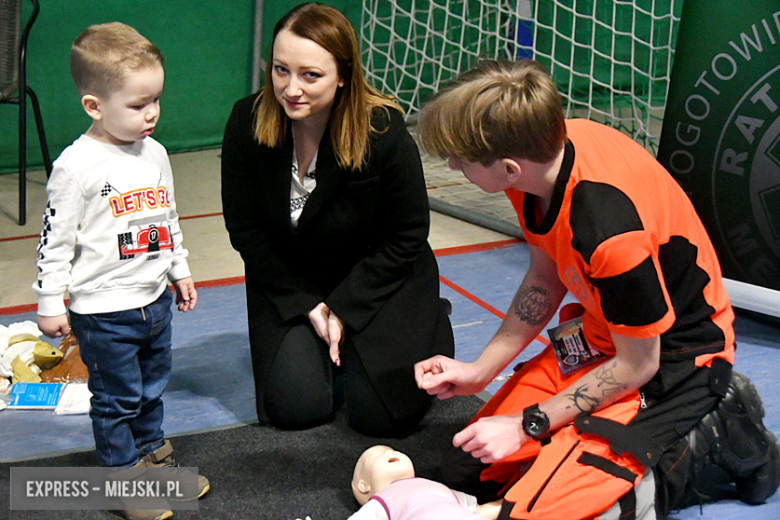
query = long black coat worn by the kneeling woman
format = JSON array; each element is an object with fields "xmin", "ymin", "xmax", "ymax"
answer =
[{"xmin": 222, "ymin": 95, "xmax": 453, "ymax": 419}]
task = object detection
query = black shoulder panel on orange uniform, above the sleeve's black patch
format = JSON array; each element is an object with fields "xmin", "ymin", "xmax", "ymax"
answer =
[{"xmin": 569, "ymin": 181, "xmax": 644, "ymax": 264}]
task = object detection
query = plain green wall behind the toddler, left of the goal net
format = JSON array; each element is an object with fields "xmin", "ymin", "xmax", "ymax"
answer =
[{"xmin": 0, "ymin": 0, "xmax": 362, "ymax": 172}]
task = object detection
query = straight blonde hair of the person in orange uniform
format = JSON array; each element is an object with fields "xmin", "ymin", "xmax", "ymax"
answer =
[{"xmin": 418, "ymin": 60, "xmax": 566, "ymax": 166}]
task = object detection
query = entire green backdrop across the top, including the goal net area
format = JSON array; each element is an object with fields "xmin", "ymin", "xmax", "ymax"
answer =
[{"xmin": 0, "ymin": 0, "xmax": 682, "ymax": 172}]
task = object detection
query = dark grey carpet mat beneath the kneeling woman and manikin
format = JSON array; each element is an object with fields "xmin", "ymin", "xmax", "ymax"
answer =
[{"xmin": 0, "ymin": 396, "xmax": 483, "ymax": 520}]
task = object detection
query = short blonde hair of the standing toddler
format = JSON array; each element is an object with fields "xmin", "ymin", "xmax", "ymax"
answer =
[{"xmin": 70, "ymin": 22, "xmax": 163, "ymax": 96}]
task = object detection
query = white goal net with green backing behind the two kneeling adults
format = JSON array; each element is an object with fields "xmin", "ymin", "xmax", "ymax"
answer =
[{"xmin": 361, "ymin": 0, "xmax": 682, "ymax": 151}]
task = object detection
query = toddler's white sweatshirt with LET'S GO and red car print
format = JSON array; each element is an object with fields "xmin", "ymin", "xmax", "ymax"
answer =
[{"xmin": 33, "ymin": 135, "xmax": 190, "ymax": 316}]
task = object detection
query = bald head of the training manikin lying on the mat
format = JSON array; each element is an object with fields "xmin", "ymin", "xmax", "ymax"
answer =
[{"xmin": 352, "ymin": 445, "xmax": 414, "ymax": 505}]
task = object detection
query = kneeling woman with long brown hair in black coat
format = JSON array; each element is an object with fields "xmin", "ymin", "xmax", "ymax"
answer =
[{"xmin": 222, "ymin": 4, "xmax": 453, "ymax": 437}]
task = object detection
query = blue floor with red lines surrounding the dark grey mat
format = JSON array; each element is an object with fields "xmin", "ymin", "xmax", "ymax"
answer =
[{"xmin": 0, "ymin": 244, "xmax": 780, "ymax": 520}]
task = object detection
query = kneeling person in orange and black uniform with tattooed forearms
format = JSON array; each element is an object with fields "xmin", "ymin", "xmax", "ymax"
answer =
[{"xmin": 415, "ymin": 60, "xmax": 780, "ymax": 520}]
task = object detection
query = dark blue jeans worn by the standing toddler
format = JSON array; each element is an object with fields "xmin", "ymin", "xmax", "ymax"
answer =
[{"xmin": 70, "ymin": 289, "xmax": 173, "ymax": 466}]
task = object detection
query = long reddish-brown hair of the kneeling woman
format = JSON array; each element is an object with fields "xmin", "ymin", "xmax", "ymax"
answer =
[{"xmin": 255, "ymin": 2, "xmax": 401, "ymax": 169}]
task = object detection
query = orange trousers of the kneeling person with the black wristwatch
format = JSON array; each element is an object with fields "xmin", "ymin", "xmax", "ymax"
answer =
[{"xmin": 471, "ymin": 347, "xmax": 645, "ymax": 520}]
